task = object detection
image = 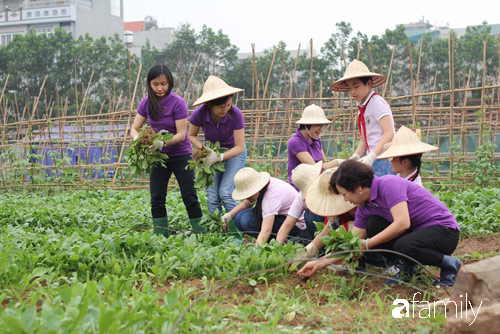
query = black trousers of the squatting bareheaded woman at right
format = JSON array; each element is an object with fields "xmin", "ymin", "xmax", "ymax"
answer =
[{"xmin": 366, "ymin": 216, "xmax": 460, "ymax": 266}]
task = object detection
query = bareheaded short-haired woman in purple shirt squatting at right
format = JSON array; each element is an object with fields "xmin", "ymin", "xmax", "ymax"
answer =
[{"xmin": 299, "ymin": 160, "xmax": 462, "ymax": 286}]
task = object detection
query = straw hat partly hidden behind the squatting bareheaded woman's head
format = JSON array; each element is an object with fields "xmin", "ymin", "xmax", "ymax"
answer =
[{"xmin": 306, "ymin": 168, "xmax": 355, "ymax": 217}]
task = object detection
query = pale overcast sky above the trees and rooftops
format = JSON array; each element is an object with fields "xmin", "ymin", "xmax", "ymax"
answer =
[{"xmin": 123, "ymin": 0, "xmax": 500, "ymax": 52}]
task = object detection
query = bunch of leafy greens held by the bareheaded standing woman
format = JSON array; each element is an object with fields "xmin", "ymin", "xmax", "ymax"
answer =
[{"xmin": 127, "ymin": 125, "xmax": 174, "ymax": 176}]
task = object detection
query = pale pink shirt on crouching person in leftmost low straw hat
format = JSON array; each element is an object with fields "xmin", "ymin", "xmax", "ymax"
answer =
[{"xmin": 262, "ymin": 177, "xmax": 297, "ymax": 218}]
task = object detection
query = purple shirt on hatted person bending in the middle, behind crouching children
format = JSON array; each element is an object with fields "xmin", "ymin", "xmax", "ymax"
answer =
[{"xmin": 287, "ymin": 128, "xmax": 323, "ymax": 191}]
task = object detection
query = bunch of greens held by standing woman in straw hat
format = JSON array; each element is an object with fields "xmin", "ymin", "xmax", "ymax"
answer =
[{"xmin": 188, "ymin": 141, "xmax": 227, "ymax": 189}]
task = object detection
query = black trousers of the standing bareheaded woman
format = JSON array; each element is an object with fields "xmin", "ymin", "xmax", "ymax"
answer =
[{"xmin": 149, "ymin": 154, "xmax": 202, "ymax": 219}]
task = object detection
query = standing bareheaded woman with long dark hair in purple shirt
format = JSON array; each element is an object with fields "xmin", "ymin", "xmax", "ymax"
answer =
[{"xmin": 130, "ymin": 65, "xmax": 202, "ymax": 237}]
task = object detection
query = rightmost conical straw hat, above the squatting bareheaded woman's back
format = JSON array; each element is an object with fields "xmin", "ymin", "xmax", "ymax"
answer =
[{"xmin": 377, "ymin": 125, "xmax": 438, "ymax": 159}]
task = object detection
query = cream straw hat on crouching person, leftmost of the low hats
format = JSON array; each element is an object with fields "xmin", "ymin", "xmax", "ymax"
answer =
[{"xmin": 233, "ymin": 167, "xmax": 271, "ymax": 201}]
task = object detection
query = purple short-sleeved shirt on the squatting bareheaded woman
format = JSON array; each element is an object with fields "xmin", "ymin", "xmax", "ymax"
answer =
[{"xmin": 354, "ymin": 175, "xmax": 460, "ymax": 231}]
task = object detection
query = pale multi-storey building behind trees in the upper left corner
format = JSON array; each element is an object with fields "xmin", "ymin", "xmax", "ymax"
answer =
[{"xmin": 0, "ymin": 0, "xmax": 123, "ymax": 45}]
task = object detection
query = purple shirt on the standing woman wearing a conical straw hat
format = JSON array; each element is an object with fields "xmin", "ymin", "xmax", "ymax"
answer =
[{"xmin": 189, "ymin": 104, "xmax": 245, "ymax": 149}]
